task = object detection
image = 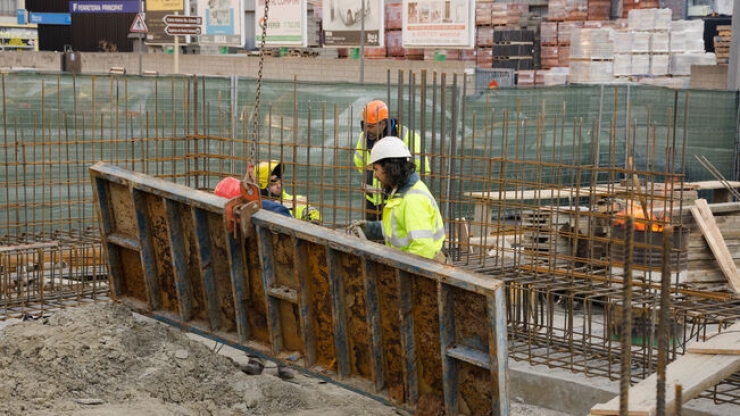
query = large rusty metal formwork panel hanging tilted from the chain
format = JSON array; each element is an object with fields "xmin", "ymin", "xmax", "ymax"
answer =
[{"xmin": 90, "ymin": 163, "xmax": 509, "ymax": 415}]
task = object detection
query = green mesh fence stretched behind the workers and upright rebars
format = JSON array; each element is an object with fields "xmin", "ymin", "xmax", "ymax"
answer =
[{"xmin": 0, "ymin": 73, "xmax": 737, "ymax": 239}]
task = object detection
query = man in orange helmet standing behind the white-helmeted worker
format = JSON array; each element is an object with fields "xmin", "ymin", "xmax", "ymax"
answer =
[{"xmin": 354, "ymin": 100, "xmax": 430, "ymax": 221}]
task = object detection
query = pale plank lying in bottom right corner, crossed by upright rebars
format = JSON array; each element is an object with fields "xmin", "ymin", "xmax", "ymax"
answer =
[{"xmin": 590, "ymin": 348, "xmax": 740, "ymax": 416}]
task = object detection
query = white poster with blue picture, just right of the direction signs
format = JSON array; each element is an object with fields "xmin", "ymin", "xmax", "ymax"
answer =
[{"xmin": 198, "ymin": 0, "xmax": 244, "ymax": 46}]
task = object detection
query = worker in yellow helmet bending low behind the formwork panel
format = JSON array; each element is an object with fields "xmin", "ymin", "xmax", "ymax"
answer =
[{"xmin": 253, "ymin": 160, "xmax": 321, "ymax": 223}]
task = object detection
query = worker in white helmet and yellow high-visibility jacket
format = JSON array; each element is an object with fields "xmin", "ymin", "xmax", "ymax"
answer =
[{"xmin": 357, "ymin": 137, "xmax": 446, "ymax": 262}]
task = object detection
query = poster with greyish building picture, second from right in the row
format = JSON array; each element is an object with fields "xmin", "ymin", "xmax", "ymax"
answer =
[{"xmin": 322, "ymin": 0, "xmax": 385, "ymax": 48}]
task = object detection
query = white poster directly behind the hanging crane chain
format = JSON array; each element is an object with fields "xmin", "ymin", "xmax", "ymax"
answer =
[{"xmin": 254, "ymin": 0, "xmax": 308, "ymax": 47}]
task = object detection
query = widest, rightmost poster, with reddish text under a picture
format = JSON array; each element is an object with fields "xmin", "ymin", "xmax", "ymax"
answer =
[{"xmin": 401, "ymin": 0, "xmax": 475, "ymax": 49}]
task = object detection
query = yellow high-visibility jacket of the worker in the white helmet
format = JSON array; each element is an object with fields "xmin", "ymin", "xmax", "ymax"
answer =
[{"xmin": 382, "ymin": 180, "xmax": 445, "ymax": 259}]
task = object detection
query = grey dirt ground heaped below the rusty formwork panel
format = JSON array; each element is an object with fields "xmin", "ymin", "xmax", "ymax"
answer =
[{"xmin": 0, "ymin": 302, "xmax": 564, "ymax": 416}]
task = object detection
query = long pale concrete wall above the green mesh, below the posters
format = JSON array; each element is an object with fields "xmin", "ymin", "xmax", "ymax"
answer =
[{"xmin": 0, "ymin": 51, "xmax": 475, "ymax": 83}]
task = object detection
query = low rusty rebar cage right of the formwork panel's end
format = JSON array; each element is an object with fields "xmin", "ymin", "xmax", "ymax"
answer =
[{"xmin": 478, "ymin": 269, "xmax": 740, "ymax": 404}]
